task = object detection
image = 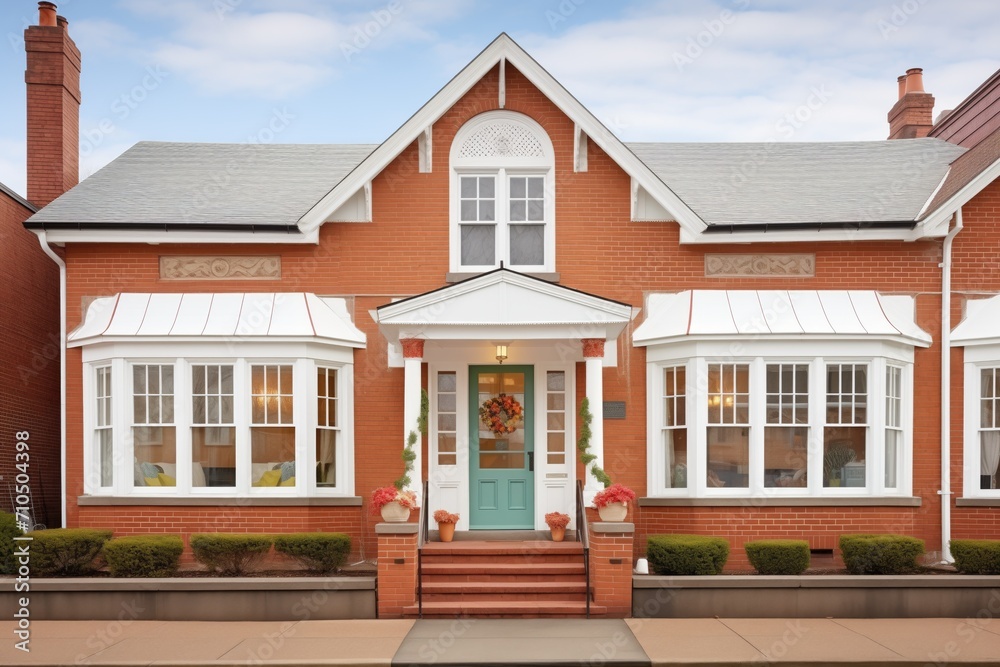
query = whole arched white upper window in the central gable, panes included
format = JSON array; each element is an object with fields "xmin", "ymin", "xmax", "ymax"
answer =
[{"xmin": 451, "ymin": 111, "xmax": 555, "ymax": 273}]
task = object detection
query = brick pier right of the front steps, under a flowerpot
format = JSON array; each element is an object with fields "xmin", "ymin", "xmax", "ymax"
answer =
[{"xmin": 584, "ymin": 521, "xmax": 635, "ymax": 618}]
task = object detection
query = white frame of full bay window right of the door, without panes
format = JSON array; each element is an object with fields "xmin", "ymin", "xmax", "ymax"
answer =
[{"xmin": 646, "ymin": 340, "xmax": 916, "ymax": 499}]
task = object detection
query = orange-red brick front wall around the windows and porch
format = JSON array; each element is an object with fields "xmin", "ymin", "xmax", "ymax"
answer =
[{"xmin": 54, "ymin": 57, "xmax": 1000, "ymax": 568}]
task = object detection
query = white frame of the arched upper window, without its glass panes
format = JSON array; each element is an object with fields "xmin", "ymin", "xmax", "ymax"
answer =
[{"xmin": 448, "ymin": 111, "xmax": 556, "ymax": 273}]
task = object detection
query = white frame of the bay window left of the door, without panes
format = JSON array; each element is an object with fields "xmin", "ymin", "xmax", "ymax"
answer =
[{"xmin": 82, "ymin": 343, "xmax": 354, "ymax": 498}]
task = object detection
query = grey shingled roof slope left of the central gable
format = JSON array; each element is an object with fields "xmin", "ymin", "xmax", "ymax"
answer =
[{"xmin": 25, "ymin": 141, "xmax": 375, "ymax": 233}]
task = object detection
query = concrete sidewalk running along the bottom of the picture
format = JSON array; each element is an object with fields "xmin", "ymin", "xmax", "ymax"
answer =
[{"xmin": 0, "ymin": 618, "xmax": 1000, "ymax": 667}]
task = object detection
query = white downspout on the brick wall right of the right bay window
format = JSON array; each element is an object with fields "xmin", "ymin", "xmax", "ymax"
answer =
[{"xmin": 938, "ymin": 207, "xmax": 962, "ymax": 563}]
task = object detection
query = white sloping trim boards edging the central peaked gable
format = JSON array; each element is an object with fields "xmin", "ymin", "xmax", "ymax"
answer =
[{"xmin": 299, "ymin": 33, "xmax": 706, "ymax": 234}]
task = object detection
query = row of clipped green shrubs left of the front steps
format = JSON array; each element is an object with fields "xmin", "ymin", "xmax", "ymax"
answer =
[{"xmin": 11, "ymin": 528, "xmax": 351, "ymax": 577}]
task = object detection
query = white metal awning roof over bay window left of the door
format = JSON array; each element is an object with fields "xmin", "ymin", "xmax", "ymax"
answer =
[{"xmin": 68, "ymin": 292, "xmax": 365, "ymax": 347}]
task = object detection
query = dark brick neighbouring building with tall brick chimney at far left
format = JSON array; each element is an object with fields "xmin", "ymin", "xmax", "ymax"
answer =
[{"xmin": 0, "ymin": 3, "xmax": 71, "ymax": 528}]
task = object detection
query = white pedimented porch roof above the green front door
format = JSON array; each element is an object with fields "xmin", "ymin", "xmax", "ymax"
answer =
[{"xmin": 372, "ymin": 268, "xmax": 633, "ymax": 343}]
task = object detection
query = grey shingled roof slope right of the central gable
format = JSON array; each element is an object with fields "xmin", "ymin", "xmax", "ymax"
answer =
[{"xmin": 626, "ymin": 139, "xmax": 965, "ymax": 232}]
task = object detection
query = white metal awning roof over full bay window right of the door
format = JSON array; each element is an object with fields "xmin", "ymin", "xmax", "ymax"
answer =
[{"xmin": 632, "ymin": 290, "xmax": 931, "ymax": 347}]
